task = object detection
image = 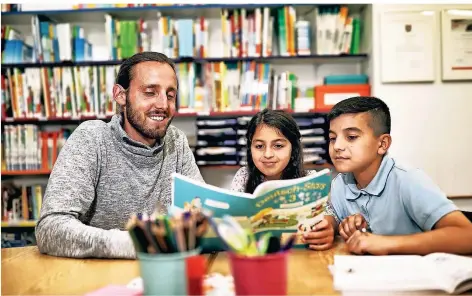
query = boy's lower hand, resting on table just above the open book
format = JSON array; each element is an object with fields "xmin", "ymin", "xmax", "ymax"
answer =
[{"xmin": 346, "ymin": 230, "xmax": 394, "ymax": 255}]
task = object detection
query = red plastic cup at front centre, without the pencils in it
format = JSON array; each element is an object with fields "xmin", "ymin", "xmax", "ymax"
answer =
[{"xmin": 228, "ymin": 252, "xmax": 288, "ymax": 295}]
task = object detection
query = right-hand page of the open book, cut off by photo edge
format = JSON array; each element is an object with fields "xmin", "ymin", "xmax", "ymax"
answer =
[{"xmin": 424, "ymin": 253, "xmax": 472, "ymax": 293}]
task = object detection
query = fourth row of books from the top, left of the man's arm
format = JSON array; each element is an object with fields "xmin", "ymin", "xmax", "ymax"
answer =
[{"xmin": 1, "ymin": 182, "xmax": 46, "ymax": 221}]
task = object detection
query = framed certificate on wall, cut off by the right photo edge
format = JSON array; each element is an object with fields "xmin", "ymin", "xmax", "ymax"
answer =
[{"xmin": 441, "ymin": 9, "xmax": 472, "ymax": 80}]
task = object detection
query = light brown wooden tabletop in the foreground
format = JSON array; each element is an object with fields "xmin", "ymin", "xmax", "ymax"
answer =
[{"xmin": 2, "ymin": 242, "xmax": 347, "ymax": 295}]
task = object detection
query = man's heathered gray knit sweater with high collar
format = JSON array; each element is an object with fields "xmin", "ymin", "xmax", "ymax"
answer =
[{"xmin": 36, "ymin": 115, "xmax": 203, "ymax": 258}]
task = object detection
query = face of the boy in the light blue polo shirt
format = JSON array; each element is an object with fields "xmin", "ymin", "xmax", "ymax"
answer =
[{"xmin": 329, "ymin": 112, "xmax": 390, "ymax": 173}]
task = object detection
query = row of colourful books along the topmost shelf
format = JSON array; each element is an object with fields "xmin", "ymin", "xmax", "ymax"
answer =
[{"xmin": 2, "ymin": 5, "xmax": 361, "ymax": 63}]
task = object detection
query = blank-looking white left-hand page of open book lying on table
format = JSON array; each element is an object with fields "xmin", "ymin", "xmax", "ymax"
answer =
[{"xmin": 330, "ymin": 255, "xmax": 444, "ymax": 292}]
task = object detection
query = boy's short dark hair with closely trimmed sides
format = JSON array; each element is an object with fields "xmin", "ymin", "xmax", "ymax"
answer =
[{"xmin": 328, "ymin": 97, "xmax": 391, "ymax": 136}]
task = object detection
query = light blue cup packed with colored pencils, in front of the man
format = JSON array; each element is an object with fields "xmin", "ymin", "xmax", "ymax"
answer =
[{"xmin": 127, "ymin": 211, "xmax": 209, "ymax": 295}]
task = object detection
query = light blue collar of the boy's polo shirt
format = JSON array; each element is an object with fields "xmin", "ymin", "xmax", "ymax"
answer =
[{"xmin": 342, "ymin": 155, "xmax": 395, "ymax": 200}]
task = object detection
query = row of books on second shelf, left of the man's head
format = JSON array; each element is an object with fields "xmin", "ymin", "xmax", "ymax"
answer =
[{"xmin": 1, "ymin": 66, "xmax": 118, "ymax": 118}]
